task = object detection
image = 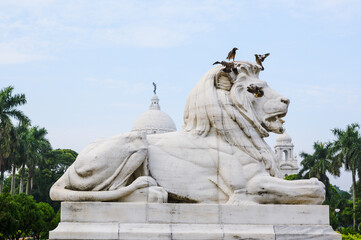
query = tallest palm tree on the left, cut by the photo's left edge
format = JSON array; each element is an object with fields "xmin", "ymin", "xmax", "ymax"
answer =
[{"xmin": 0, "ymin": 86, "xmax": 30, "ymax": 193}]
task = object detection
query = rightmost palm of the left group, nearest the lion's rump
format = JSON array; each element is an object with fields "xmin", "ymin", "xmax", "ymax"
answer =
[{"xmin": 26, "ymin": 126, "xmax": 51, "ymax": 194}]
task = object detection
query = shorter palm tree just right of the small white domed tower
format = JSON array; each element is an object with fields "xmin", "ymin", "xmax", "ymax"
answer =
[{"xmin": 299, "ymin": 142, "xmax": 341, "ymax": 197}]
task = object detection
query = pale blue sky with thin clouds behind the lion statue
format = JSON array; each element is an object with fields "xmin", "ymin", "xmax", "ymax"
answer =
[{"xmin": 0, "ymin": 0, "xmax": 361, "ymax": 190}]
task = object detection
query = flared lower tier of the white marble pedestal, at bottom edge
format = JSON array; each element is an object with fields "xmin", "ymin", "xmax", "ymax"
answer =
[{"xmin": 49, "ymin": 222, "xmax": 341, "ymax": 240}]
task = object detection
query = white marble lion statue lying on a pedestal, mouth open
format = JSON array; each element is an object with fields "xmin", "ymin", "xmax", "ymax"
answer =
[{"xmin": 50, "ymin": 61, "xmax": 325, "ymax": 204}]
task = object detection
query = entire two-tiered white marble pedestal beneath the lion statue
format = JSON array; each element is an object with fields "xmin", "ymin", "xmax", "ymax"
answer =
[{"xmin": 49, "ymin": 202, "xmax": 341, "ymax": 240}]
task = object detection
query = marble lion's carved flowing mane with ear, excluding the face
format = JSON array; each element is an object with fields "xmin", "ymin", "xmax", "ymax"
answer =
[{"xmin": 183, "ymin": 62, "xmax": 279, "ymax": 176}]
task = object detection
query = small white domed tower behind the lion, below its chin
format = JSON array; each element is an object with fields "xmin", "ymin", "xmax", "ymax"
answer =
[{"xmin": 274, "ymin": 132, "xmax": 299, "ymax": 178}]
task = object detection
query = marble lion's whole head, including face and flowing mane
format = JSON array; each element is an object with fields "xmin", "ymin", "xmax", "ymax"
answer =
[{"xmin": 183, "ymin": 61, "xmax": 289, "ymax": 175}]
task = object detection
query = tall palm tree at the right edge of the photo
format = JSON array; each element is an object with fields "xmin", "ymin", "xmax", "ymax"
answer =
[{"xmin": 331, "ymin": 123, "xmax": 361, "ymax": 229}]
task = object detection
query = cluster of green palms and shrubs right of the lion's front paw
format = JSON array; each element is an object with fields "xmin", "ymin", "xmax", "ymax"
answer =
[{"xmin": 298, "ymin": 123, "xmax": 361, "ymax": 229}]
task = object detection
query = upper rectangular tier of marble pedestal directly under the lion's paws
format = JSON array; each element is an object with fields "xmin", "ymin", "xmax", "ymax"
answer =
[{"xmin": 61, "ymin": 202, "xmax": 329, "ymax": 225}]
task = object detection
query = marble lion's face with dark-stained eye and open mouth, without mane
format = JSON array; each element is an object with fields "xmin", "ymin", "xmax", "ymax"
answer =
[{"xmin": 236, "ymin": 77, "xmax": 290, "ymax": 133}]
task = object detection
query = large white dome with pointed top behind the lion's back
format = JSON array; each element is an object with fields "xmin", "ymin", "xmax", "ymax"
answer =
[{"xmin": 132, "ymin": 94, "xmax": 177, "ymax": 134}]
